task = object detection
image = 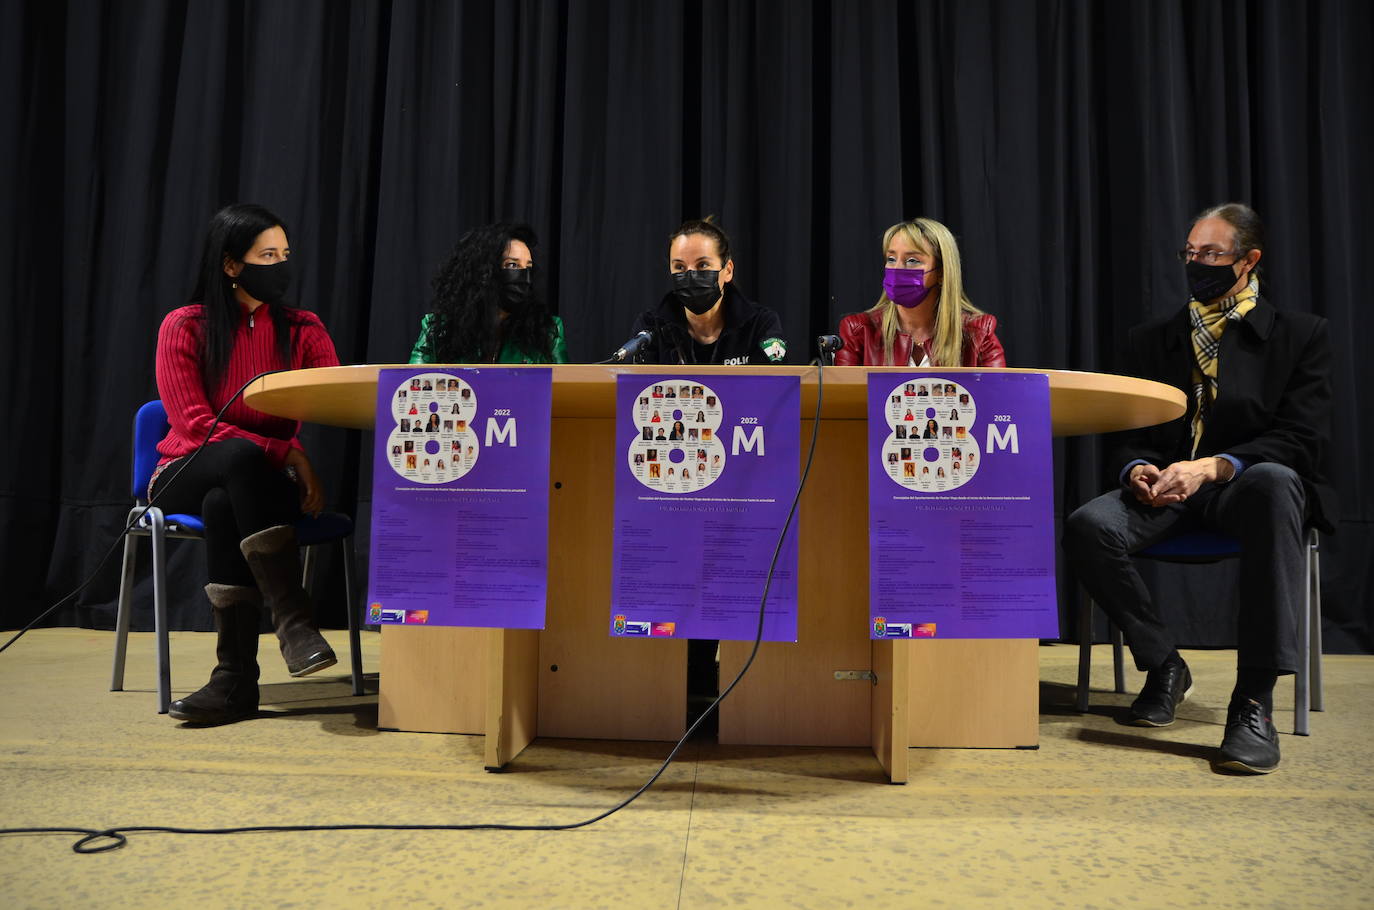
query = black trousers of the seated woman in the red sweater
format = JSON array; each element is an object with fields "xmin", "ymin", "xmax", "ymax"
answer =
[{"xmin": 153, "ymin": 439, "xmax": 301, "ymax": 586}]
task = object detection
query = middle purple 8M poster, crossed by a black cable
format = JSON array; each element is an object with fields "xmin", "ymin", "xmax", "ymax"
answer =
[{"xmin": 610, "ymin": 374, "xmax": 801, "ymax": 642}]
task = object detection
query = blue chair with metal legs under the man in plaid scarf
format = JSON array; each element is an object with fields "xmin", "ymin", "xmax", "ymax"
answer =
[{"xmin": 1077, "ymin": 528, "xmax": 1322, "ymax": 737}]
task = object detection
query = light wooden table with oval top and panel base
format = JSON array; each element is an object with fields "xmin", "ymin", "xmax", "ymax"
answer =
[{"xmin": 245, "ymin": 364, "xmax": 1186, "ymax": 782}]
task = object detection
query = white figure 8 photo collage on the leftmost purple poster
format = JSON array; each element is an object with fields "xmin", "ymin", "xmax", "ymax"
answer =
[{"xmin": 386, "ymin": 373, "xmax": 481, "ymax": 484}]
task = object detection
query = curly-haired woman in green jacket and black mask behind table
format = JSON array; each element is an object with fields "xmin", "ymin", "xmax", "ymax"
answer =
[{"xmin": 411, "ymin": 224, "xmax": 567, "ymax": 363}]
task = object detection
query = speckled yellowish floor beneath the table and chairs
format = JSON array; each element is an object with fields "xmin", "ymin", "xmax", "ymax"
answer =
[{"xmin": 0, "ymin": 630, "xmax": 1374, "ymax": 910}]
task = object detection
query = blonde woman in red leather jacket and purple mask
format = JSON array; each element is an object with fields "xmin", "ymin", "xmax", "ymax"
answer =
[{"xmin": 835, "ymin": 219, "xmax": 1007, "ymax": 367}]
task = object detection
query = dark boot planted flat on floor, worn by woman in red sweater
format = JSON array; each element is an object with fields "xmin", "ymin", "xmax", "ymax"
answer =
[{"xmin": 168, "ymin": 584, "xmax": 261, "ymax": 724}]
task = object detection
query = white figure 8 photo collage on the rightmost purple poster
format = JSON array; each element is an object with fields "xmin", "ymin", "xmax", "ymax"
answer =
[{"xmin": 882, "ymin": 379, "xmax": 978, "ymax": 493}]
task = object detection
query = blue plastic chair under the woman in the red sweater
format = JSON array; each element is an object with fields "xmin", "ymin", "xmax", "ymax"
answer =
[{"xmin": 110, "ymin": 400, "xmax": 363, "ymax": 713}]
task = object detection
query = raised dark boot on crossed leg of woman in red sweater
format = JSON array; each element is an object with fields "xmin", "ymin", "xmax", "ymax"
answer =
[{"xmin": 239, "ymin": 525, "xmax": 338, "ymax": 676}]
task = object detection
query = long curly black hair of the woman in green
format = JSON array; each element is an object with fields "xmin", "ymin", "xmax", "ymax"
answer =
[{"xmin": 429, "ymin": 223, "xmax": 554, "ymax": 363}]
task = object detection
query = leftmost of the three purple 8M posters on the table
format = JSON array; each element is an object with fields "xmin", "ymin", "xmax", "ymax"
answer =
[{"xmin": 367, "ymin": 367, "xmax": 552, "ymax": 628}]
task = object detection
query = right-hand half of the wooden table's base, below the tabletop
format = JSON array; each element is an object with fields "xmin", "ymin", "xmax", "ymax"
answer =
[{"xmin": 720, "ymin": 421, "xmax": 1039, "ymax": 753}]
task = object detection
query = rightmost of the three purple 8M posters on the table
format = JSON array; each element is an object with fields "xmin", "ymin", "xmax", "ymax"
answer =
[{"xmin": 868, "ymin": 373, "xmax": 1059, "ymax": 638}]
